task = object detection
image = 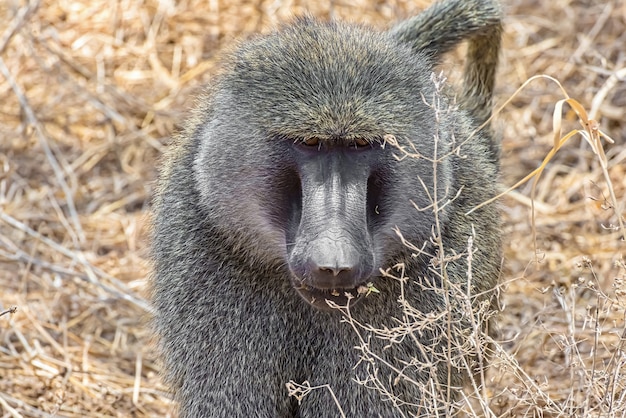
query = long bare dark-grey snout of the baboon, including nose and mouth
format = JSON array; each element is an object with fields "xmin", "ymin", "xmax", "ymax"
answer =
[{"xmin": 288, "ymin": 152, "xmax": 375, "ymax": 308}]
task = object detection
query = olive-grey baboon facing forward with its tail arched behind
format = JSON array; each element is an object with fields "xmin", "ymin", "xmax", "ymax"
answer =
[{"xmin": 152, "ymin": 0, "xmax": 502, "ymax": 418}]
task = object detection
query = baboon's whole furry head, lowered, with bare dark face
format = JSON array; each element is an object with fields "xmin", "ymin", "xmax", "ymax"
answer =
[{"xmin": 195, "ymin": 20, "xmax": 450, "ymax": 309}]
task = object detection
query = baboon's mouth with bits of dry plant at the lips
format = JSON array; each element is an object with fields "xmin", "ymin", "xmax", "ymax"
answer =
[{"xmin": 292, "ymin": 279, "xmax": 367, "ymax": 311}]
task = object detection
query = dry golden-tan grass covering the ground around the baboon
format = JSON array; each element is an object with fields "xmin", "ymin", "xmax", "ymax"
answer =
[{"xmin": 0, "ymin": 0, "xmax": 626, "ymax": 417}]
